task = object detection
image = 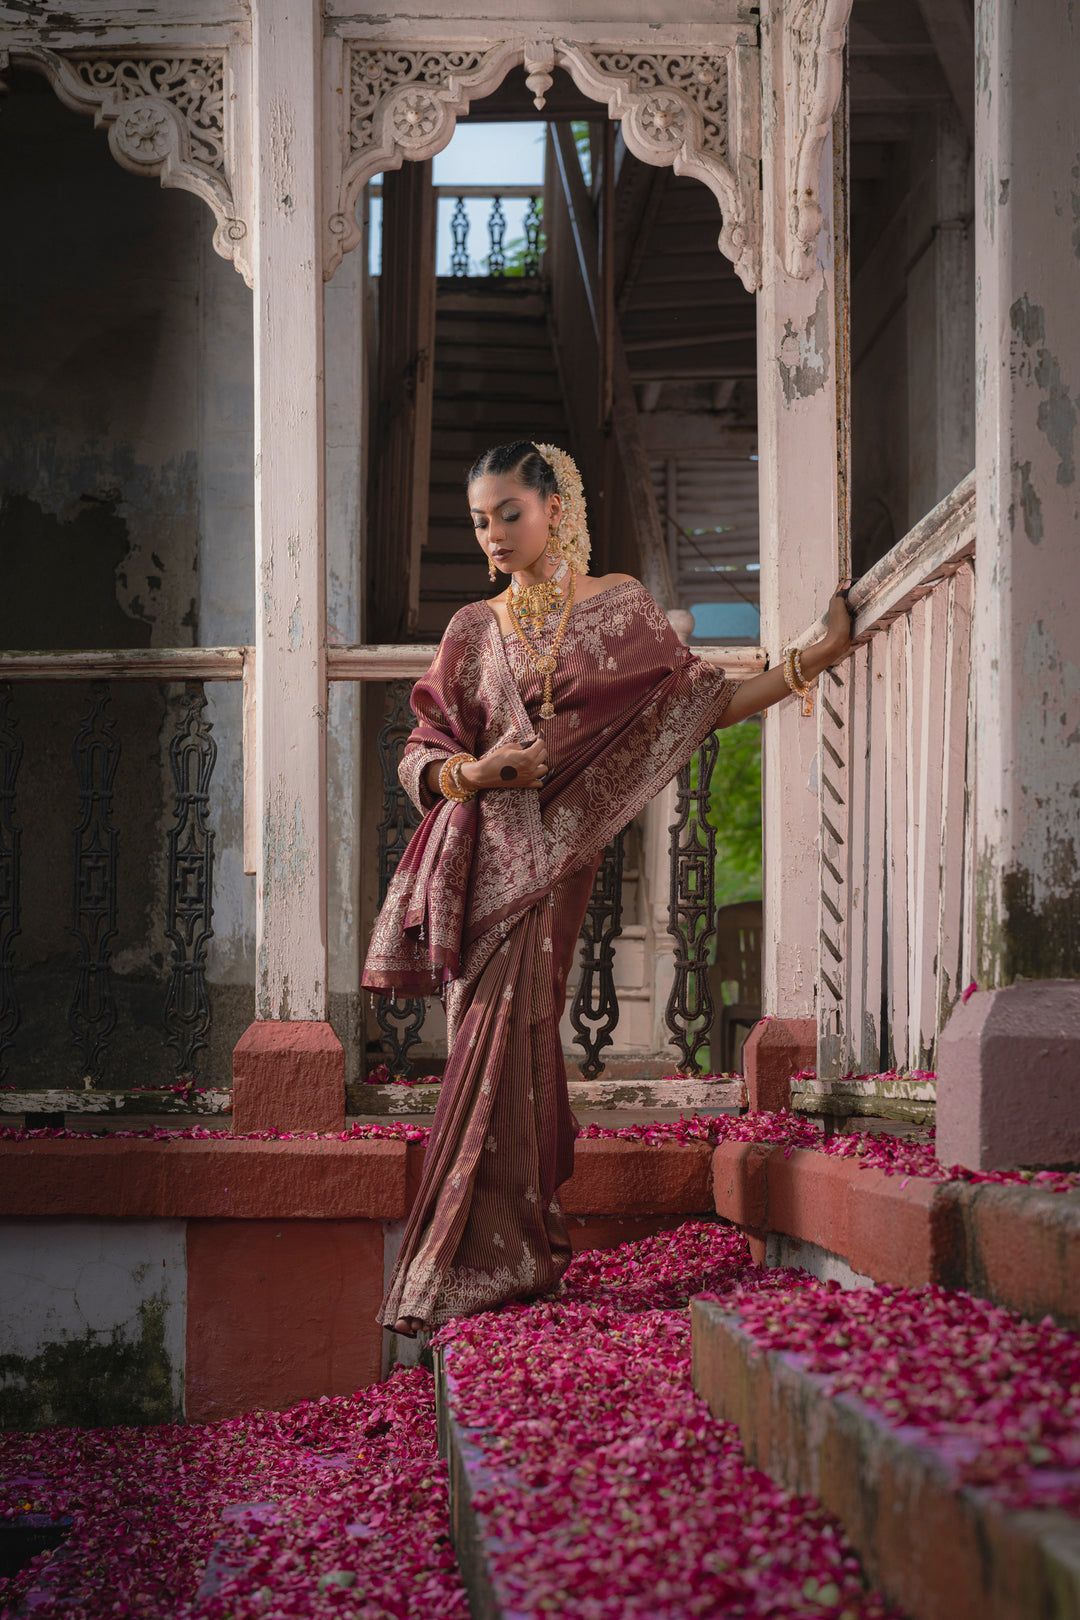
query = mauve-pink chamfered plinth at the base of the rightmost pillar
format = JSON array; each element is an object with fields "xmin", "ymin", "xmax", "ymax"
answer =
[{"xmin": 938, "ymin": 978, "xmax": 1080, "ymax": 1170}]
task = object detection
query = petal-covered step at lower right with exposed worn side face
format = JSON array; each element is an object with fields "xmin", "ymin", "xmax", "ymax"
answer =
[{"xmin": 691, "ymin": 1273, "xmax": 1080, "ymax": 1620}]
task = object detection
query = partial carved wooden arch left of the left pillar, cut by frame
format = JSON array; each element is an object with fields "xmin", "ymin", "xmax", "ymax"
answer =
[{"xmin": 0, "ymin": 45, "xmax": 251, "ymax": 287}]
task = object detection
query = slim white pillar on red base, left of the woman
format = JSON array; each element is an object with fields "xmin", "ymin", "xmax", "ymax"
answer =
[{"xmin": 233, "ymin": 0, "xmax": 343, "ymax": 1131}]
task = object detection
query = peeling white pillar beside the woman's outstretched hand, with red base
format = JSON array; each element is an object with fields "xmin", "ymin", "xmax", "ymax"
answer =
[{"xmin": 745, "ymin": 0, "xmax": 839, "ymax": 1106}]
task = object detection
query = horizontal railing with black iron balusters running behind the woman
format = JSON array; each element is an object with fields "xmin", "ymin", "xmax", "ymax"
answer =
[{"xmin": 0, "ymin": 646, "xmax": 763, "ymax": 1087}]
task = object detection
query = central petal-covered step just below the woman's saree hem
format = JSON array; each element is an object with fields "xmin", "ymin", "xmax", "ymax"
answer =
[{"xmin": 437, "ymin": 1221, "xmax": 897, "ymax": 1620}]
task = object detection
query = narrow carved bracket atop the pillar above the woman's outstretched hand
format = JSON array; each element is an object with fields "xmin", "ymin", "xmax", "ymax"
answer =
[{"xmin": 784, "ymin": 0, "xmax": 852, "ymax": 280}]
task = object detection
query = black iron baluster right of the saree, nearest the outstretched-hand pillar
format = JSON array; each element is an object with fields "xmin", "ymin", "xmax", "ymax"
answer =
[{"xmin": 665, "ymin": 734, "xmax": 719, "ymax": 1074}]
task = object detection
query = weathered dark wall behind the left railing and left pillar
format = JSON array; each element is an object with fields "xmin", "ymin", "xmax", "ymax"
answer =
[{"xmin": 0, "ymin": 73, "xmax": 372, "ymax": 1085}]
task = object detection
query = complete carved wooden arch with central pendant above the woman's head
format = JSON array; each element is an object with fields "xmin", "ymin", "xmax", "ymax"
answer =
[{"xmin": 333, "ymin": 39, "xmax": 761, "ymax": 292}]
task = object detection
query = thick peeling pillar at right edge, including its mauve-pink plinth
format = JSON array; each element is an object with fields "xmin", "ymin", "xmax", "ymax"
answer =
[{"xmin": 938, "ymin": 0, "xmax": 1080, "ymax": 1168}]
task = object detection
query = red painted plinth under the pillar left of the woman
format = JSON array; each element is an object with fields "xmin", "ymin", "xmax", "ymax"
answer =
[{"xmin": 233, "ymin": 1019, "xmax": 345, "ymax": 1136}]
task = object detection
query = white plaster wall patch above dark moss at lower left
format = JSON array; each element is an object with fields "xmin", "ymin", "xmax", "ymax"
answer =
[{"xmin": 0, "ymin": 1220, "xmax": 188, "ymax": 1405}]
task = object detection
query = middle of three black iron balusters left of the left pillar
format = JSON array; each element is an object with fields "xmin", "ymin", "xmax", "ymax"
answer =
[{"xmin": 68, "ymin": 680, "xmax": 120, "ymax": 1082}]
